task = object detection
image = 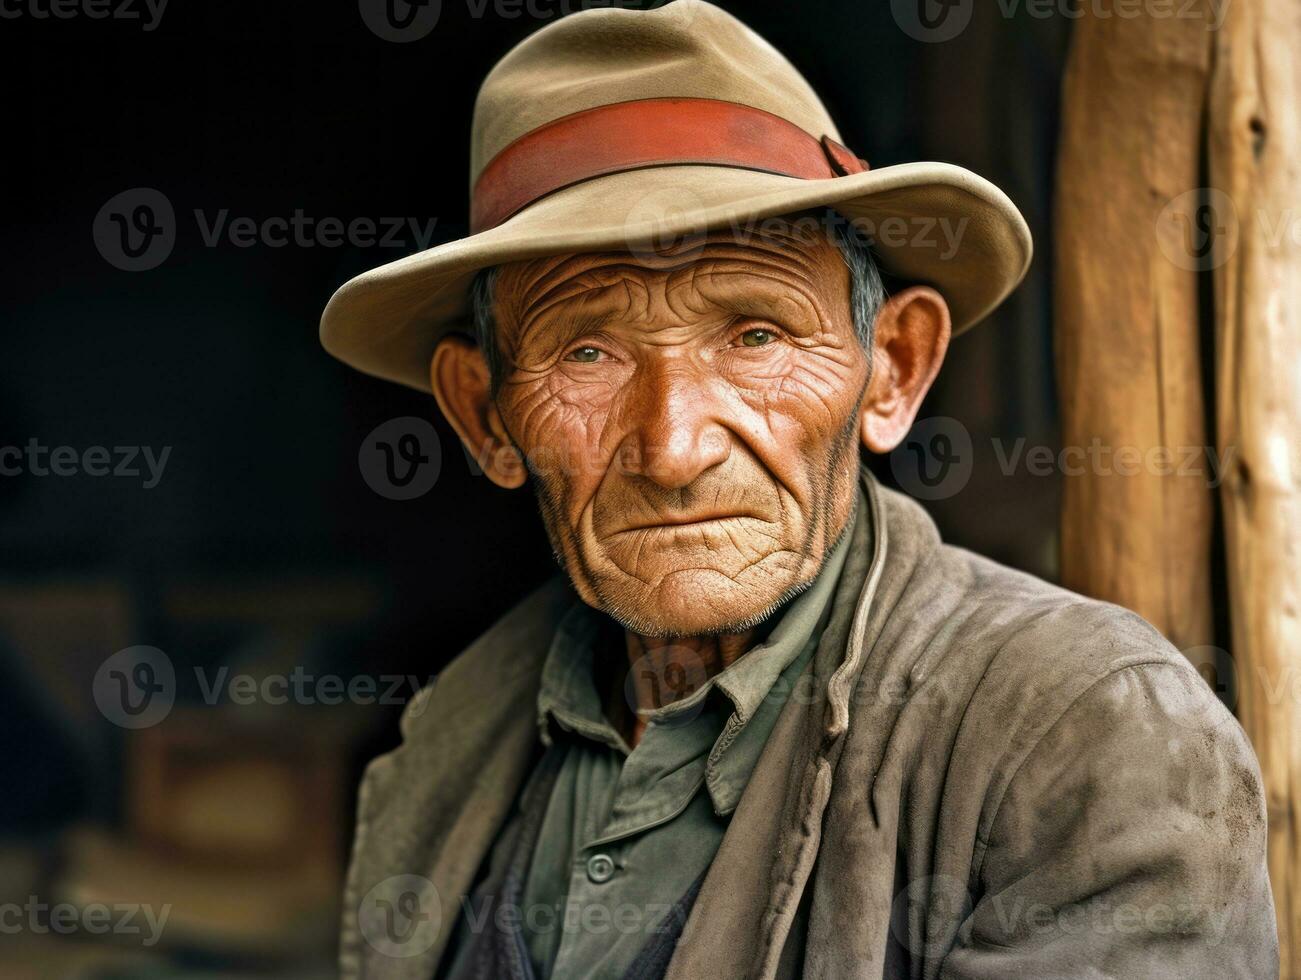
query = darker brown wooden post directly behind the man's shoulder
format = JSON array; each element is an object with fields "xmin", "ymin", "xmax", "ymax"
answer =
[{"xmin": 1055, "ymin": 7, "xmax": 1214, "ymax": 649}]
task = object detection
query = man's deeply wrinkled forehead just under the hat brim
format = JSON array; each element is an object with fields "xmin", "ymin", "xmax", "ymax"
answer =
[{"xmin": 496, "ymin": 217, "xmax": 848, "ymax": 328}]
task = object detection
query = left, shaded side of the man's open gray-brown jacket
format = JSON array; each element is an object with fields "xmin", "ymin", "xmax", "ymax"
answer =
[{"xmin": 340, "ymin": 579, "xmax": 574, "ymax": 980}]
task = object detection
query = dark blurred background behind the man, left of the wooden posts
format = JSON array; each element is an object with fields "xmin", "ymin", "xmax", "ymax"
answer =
[{"xmin": 0, "ymin": 0, "xmax": 1069, "ymax": 976}]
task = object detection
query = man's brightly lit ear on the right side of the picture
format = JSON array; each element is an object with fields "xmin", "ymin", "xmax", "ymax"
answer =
[{"xmin": 859, "ymin": 286, "xmax": 952, "ymax": 453}]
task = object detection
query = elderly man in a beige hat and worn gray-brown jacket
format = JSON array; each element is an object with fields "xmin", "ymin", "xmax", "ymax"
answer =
[{"xmin": 321, "ymin": 0, "xmax": 1278, "ymax": 980}]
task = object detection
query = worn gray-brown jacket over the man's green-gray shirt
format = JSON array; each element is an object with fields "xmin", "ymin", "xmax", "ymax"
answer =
[{"xmin": 341, "ymin": 474, "xmax": 1279, "ymax": 980}]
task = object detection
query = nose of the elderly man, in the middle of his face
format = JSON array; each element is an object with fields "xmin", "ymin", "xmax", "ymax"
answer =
[{"xmin": 619, "ymin": 363, "xmax": 731, "ymax": 489}]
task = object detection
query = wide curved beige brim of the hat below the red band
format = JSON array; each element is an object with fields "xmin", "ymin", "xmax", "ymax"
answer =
[{"xmin": 320, "ymin": 163, "xmax": 1032, "ymax": 392}]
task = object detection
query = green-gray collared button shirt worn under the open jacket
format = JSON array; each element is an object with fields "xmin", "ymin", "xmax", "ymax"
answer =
[{"xmin": 519, "ymin": 506, "xmax": 861, "ymax": 980}]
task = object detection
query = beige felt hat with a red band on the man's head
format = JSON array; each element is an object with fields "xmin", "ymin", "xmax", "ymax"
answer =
[{"xmin": 314, "ymin": 0, "xmax": 1030, "ymax": 390}]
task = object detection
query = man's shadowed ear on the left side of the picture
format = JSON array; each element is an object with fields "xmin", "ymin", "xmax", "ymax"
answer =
[{"xmin": 429, "ymin": 333, "xmax": 528, "ymax": 489}]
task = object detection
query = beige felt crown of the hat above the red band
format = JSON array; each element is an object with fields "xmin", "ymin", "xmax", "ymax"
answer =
[{"xmin": 470, "ymin": 0, "xmax": 839, "ymax": 187}]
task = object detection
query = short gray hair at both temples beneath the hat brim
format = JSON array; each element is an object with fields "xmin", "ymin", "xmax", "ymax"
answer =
[{"xmin": 470, "ymin": 208, "xmax": 887, "ymax": 394}]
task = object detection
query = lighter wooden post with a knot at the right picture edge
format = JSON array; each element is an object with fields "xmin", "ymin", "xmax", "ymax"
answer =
[{"xmin": 1209, "ymin": 0, "xmax": 1301, "ymax": 977}]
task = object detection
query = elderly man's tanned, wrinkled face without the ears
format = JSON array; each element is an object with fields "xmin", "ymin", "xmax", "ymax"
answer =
[{"xmin": 483, "ymin": 226, "xmax": 869, "ymax": 636}]
